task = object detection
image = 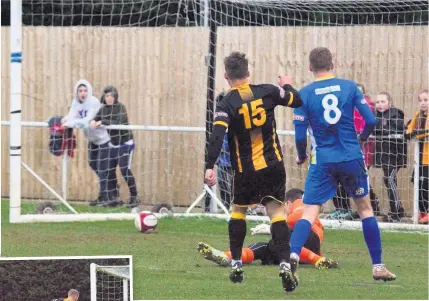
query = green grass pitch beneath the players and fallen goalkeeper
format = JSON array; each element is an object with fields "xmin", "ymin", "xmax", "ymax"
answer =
[{"xmin": 2, "ymin": 201, "xmax": 428, "ymax": 300}]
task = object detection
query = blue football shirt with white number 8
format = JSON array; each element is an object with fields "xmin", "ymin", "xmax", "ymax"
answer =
[{"xmin": 293, "ymin": 76, "xmax": 375, "ymax": 164}]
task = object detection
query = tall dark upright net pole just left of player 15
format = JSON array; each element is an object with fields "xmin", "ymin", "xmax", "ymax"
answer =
[{"xmin": 203, "ymin": 0, "xmax": 217, "ymax": 212}]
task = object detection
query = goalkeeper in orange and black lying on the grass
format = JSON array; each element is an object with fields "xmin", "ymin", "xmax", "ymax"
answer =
[{"xmin": 197, "ymin": 188, "xmax": 338, "ymax": 269}]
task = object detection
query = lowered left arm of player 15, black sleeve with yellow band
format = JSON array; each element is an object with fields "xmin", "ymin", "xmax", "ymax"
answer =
[{"xmin": 206, "ymin": 98, "xmax": 229, "ymax": 185}]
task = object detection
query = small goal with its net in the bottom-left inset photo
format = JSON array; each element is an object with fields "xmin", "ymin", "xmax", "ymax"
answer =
[{"xmin": 90, "ymin": 263, "xmax": 132, "ymax": 301}]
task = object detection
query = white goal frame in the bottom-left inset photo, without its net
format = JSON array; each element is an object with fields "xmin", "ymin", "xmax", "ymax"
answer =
[{"xmin": 90, "ymin": 263, "xmax": 132, "ymax": 301}]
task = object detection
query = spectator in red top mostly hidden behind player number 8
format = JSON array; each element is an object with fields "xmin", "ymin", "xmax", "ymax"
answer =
[{"xmin": 328, "ymin": 84, "xmax": 381, "ymax": 220}]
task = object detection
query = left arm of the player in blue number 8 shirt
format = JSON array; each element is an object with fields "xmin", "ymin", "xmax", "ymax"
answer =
[{"xmin": 293, "ymin": 90, "xmax": 308, "ymax": 164}]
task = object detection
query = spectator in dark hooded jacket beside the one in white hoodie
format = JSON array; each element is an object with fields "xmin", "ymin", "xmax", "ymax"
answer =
[{"xmin": 91, "ymin": 86, "xmax": 140, "ymax": 207}]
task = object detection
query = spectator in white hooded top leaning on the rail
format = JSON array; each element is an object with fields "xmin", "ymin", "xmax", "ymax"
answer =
[{"xmin": 61, "ymin": 79, "xmax": 113, "ymax": 206}]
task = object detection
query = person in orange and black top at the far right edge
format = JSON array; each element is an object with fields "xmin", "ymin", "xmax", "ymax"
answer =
[{"xmin": 406, "ymin": 90, "xmax": 429, "ymax": 224}]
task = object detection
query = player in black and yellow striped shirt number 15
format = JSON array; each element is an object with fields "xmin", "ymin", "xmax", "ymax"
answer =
[{"xmin": 205, "ymin": 52, "xmax": 301, "ymax": 292}]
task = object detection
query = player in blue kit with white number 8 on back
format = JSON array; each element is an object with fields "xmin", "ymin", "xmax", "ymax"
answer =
[{"xmin": 290, "ymin": 47, "xmax": 396, "ymax": 281}]
